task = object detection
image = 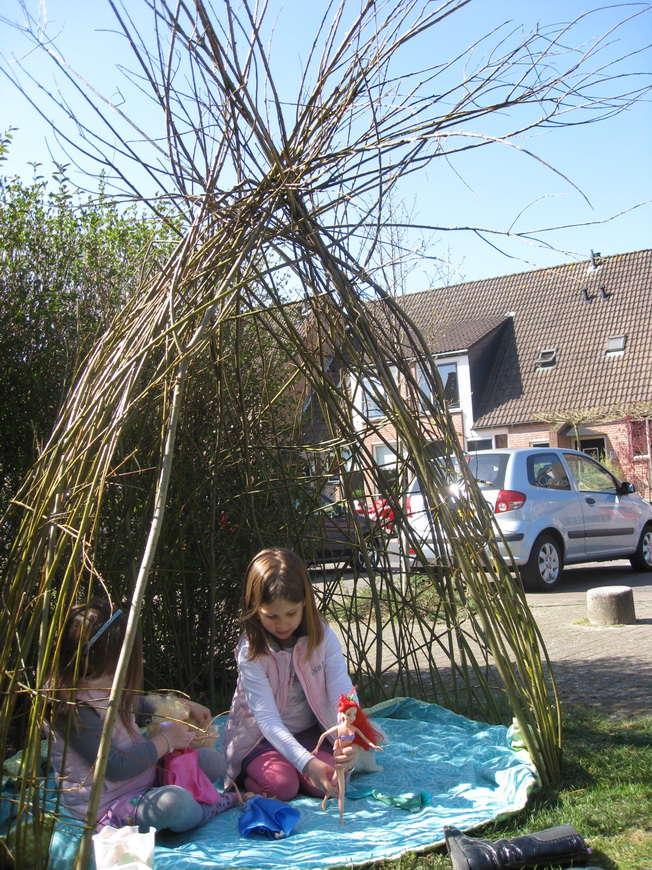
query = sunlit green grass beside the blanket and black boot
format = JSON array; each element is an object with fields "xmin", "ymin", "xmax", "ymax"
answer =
[{"xmin": 354, "ymin": 707, "xmax": 652, "ymax": 870}]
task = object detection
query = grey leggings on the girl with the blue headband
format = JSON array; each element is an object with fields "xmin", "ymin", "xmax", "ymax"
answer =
[{"xmin": 136, "ymin": 749, "xmax": 232, "ymax": 833}]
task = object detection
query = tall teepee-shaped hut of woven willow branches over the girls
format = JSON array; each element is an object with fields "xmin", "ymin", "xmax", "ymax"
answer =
[{"xmin": 0, "ymin": 0, "xmax": 648, "ymax": 866}]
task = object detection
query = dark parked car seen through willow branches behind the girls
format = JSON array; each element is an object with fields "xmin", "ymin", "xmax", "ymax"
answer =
[{"xmin": 295, "ymin": 493, "xmax": 381, "ymax": 570}]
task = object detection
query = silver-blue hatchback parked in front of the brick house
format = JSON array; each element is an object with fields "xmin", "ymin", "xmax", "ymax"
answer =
[{"xmin": 410, "ymin": 447, "xmax": 652, "ymax": 591}]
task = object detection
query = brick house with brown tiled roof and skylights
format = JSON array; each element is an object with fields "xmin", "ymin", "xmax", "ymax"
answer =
[{"xmin": 352, "ymin": 250, "xmax": 652, "ymax": 499}]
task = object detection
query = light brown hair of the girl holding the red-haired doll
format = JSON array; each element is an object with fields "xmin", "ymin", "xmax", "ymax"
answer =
[{"xmin": 242, "ymin": 547, "xmax": 324, "ymax": 659}]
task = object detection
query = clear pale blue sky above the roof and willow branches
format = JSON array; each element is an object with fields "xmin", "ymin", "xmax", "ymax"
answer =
[{"xmin": 0, "ymin": 0, "xmax": 652, "ymax": 290}]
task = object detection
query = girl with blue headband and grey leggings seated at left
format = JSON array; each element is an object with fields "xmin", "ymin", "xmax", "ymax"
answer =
[{"xmin": 49, "ymin": 598, "xmax": 238, "ymax": 832}]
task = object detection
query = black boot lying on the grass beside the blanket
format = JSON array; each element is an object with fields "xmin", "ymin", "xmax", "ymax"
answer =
[{"xmin": 444, "ymin": 825, "xmax": 591, "ymax": 870}]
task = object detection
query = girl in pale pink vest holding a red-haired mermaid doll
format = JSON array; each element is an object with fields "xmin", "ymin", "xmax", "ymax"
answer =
[{"xmin": 222, "ymin": 549, "xmax": 357, "ymax": 801}]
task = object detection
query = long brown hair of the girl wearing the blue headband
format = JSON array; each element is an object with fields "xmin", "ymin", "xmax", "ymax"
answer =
[{"xmin": 49, "ymin": 598, "xmax": 143, "ymax": 731}]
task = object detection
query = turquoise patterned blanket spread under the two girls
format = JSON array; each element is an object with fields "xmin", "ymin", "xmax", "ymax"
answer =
[{"xmin": 10, "ymin": 698, "xmax": 537, "ymax": 870}]
